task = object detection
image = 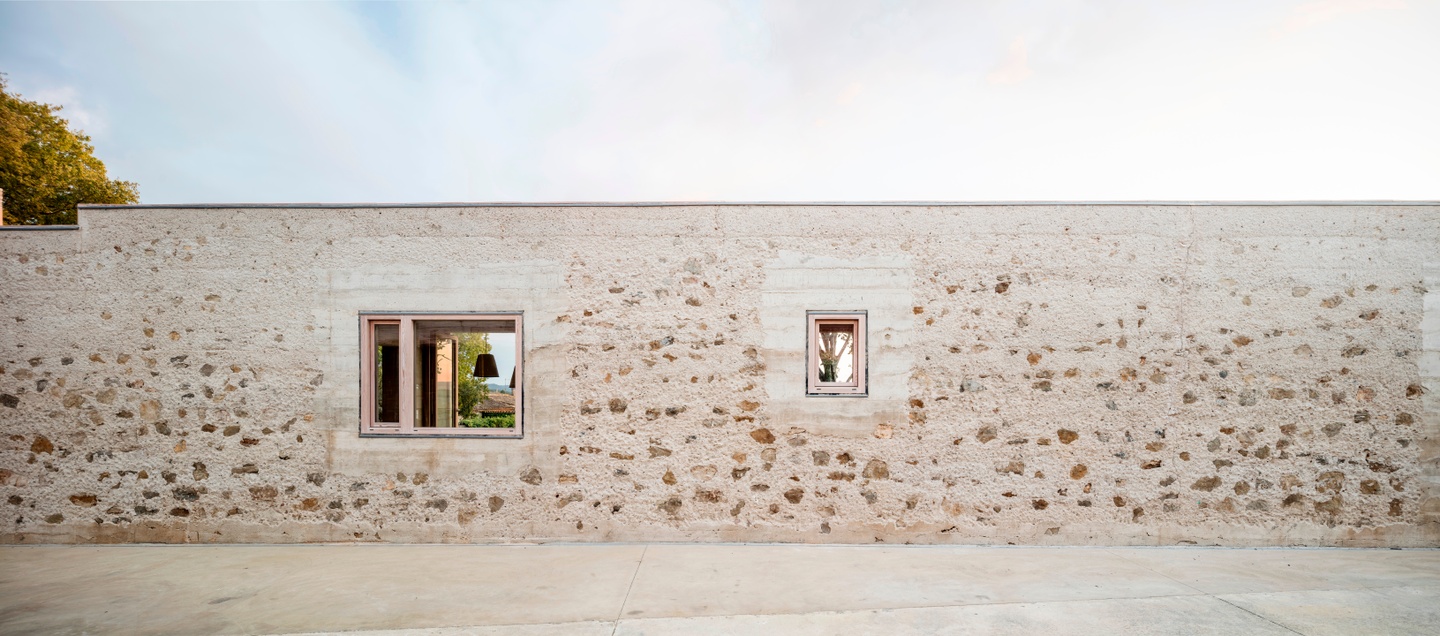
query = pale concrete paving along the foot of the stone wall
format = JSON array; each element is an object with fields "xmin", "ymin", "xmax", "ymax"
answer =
[{"xmin": 0, "ymin": 544, "xmax": 1440, "ymax": 636}]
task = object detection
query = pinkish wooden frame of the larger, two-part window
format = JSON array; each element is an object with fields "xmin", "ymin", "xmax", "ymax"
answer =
[{"xmin": 360, "ymin": 311, "xmax": 526, "ymax": 439}]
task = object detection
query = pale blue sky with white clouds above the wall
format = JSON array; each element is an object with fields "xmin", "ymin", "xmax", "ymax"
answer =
[{"xmin": 0, "ymin": 0, "xmax": 1440, "ymax": 203}]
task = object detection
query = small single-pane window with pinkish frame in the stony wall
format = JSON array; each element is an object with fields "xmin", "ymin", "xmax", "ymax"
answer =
[{"xmin": 805, "ymin": 311, "xmax": 868, "ymax": 397}]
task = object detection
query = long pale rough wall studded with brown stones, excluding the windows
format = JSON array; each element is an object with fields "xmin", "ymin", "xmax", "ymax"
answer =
[{"xmin": 0, "ymin": 204, "xmax": 1440, "ymax": 547}]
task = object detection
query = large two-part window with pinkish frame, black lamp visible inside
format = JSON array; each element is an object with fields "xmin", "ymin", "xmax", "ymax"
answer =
[{"xmin": 360, "ymin": 314, "xmax": 524, "ymax": 437}]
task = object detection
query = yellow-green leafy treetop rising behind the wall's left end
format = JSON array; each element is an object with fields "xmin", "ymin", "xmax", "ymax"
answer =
[{"xmin": 0, "ymin": 75, "xmax": 140, "ymax": 224}]
